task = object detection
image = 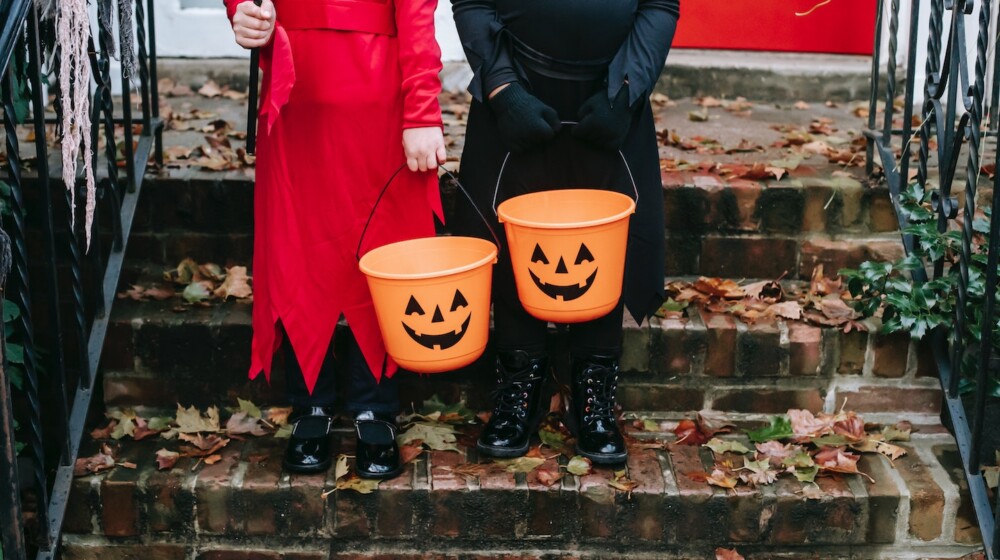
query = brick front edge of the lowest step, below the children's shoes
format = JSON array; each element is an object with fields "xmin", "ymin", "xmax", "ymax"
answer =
[{"xmin": 66, "ymin": 436, "xmax": 978, "ymax": 550}]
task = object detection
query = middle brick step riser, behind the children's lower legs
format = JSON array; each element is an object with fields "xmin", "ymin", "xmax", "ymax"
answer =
[{"xmin": 102, "ymin": 290, "xmax": 941, "ymax": 418}]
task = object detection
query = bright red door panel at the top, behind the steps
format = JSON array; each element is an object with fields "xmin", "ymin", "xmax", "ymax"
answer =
[{"xmin": 674, "ymin": 0, "xmax": 876, "ymax": 55}]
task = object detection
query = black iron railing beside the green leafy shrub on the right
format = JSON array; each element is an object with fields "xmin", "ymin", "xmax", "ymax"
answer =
[{"xmin": 866, "ymin": 0, "xmax": 1000, "ymax": 560}]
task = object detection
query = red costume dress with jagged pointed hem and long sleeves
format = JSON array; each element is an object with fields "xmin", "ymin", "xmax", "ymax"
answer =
[{"xmin": 225, "ymin": 0, "xmax": 441, "ymax": 392}]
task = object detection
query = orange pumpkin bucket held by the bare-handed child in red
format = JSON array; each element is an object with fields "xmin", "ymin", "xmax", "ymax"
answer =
[{"xmin": 359, "ymin": 237, "xmax": 497, "ymax": 373}]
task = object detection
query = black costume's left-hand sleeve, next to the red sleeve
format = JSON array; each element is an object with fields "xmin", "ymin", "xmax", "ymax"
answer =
[{"xmin": 451, "ymin": 0, "xmax": 518, "ymax": 102}]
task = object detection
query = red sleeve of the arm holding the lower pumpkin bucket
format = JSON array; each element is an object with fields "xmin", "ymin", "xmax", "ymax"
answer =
[{"xmin": 394, "ymin": 0, "xmax": 441, "ymax": 128}]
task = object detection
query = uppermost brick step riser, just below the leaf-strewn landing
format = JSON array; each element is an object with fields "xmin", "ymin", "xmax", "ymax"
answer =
[{"xmin": 128, "ymin": 169, "xmax": 898, "ymax": 270}]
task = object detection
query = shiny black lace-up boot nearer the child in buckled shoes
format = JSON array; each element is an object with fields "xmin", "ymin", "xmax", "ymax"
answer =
[{"xmin": 476, "ymin": 351, "xmax": 549, "ymax": 457}]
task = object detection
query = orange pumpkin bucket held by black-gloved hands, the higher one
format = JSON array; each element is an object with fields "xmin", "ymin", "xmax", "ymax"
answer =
[{"xmin": 497, "ymin": 189, "xmax": 635, "ymax": 323}]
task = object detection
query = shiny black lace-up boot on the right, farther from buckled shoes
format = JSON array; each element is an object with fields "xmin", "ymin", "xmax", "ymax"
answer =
[{"xmin": 571, "ymin": 355, "xmax": 628, "ymax": 465}]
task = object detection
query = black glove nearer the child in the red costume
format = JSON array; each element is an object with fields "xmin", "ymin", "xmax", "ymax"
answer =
[{"xmin": 490, "ymin": 82, "xmax": 560, "ymax": 152}]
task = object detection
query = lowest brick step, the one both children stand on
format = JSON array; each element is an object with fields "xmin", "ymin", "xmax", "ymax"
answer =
[{"xmin": 63, "ymin": 430, "xmax": 981, "ymax": 560}]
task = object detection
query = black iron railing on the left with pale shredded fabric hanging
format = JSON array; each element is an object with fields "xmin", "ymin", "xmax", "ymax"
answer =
[{"xmin": 0, "ymin": 0, "xmax": 163, "ymax": 560}]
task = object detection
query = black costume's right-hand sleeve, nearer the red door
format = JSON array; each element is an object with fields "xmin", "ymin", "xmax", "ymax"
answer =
[{"xmin": 608, "ymin": 0, "xmax": 680, "ymax": 105}]
